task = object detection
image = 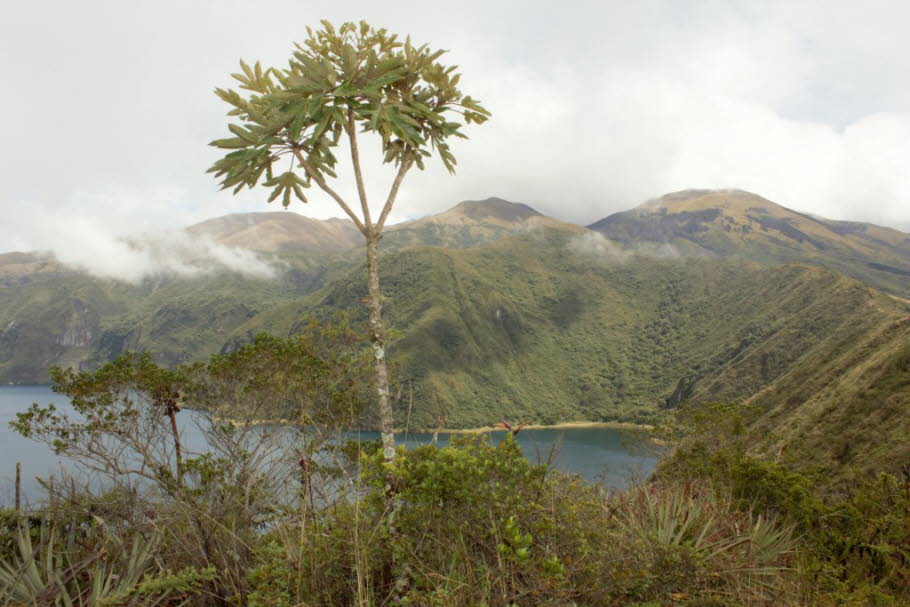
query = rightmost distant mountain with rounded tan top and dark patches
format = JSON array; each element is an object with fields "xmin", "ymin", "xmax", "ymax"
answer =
[{"xmin": 589, "ymin": 190, "xmax": 910, "ymax": 297}]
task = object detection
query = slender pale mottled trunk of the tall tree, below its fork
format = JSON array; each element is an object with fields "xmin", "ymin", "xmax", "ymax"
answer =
[{"xmin": 366, "ymin": 234, "xmax": 395, "ymax": 462}]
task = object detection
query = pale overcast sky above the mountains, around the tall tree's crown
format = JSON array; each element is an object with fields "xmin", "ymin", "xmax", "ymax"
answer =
[{"xmin": 0, "ymin": 0, "xmax": 910, "ymax": 258}]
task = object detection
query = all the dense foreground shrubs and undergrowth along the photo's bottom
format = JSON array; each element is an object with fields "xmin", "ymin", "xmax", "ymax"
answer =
[{"xmin": 0, "ymin": 324, "xmax": 910, "ymax": 607}]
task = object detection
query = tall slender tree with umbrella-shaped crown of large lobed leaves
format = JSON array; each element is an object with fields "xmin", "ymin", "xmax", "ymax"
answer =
[{"xmin": 209, "ymin": 21, "xmax": 490, "ymax": 461}]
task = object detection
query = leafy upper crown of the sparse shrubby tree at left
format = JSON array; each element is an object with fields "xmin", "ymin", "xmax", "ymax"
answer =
[{"xmin": 10, "ymin": 326, "xmax": 369, "ymax": 496}]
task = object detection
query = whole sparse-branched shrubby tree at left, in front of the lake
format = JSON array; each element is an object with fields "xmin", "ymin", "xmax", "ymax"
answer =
[{"xmin": 12, "ymin": 328, "xmax": 371, "ymax": 604}]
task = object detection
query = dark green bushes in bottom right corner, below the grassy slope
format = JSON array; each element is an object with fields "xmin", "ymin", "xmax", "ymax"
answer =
[{"xmin": 657, "ymin": 404, "xmax": 910, "ymax": 605}]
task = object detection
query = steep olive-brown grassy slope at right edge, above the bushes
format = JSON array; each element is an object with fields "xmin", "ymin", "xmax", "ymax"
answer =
[{"xmin": 751, "ymin": 313, "xmax": 910, "ymax": 479}]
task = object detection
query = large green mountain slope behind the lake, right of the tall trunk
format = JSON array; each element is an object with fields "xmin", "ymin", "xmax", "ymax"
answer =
[{"xmin": 230, "ymin": 223, "xmax": 904, "ymax": 436}]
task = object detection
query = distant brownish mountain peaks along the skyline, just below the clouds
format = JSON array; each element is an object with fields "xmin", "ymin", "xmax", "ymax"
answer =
[{"xmin": 0, "ymin": 189, "xmax": 910, "ymax": 280}]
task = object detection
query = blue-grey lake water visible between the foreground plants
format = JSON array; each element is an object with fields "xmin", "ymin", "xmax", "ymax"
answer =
[{"xmin": 0, "ymin": 385, "xmax": 657, "ymax": 506}]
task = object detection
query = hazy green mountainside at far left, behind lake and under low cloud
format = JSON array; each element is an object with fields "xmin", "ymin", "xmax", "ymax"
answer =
[{"xmin": 0, "ymin": 270, "xmax": 304, "ymax": 383}]
